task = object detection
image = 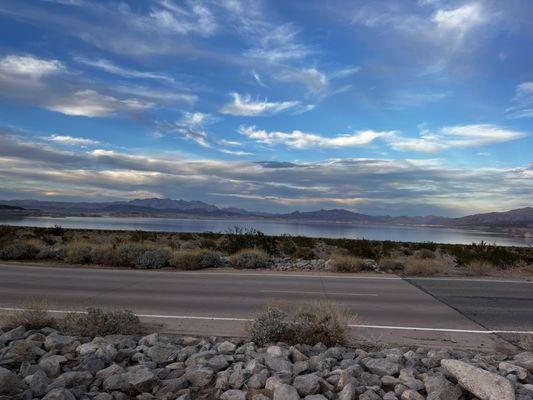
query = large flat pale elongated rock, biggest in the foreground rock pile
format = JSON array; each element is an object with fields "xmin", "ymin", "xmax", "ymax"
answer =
[{"xmin": 441, "ymin": 359, "xmax": 515, "ymax": 400}]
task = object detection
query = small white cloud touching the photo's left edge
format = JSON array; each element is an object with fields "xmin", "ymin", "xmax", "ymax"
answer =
[{"xmin": 0, "ymin": 54, "xmax": 65, "ymax": 79}]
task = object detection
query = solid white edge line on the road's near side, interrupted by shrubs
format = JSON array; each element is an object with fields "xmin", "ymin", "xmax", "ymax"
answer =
[{"xmin": 0, "ymin": 307, "xmax": 533, "ymax": 335}]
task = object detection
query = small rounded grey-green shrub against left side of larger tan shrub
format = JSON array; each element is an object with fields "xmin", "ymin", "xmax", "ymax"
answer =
[{"xmin": 248, "ymin": 306, "xmax": 287, "ymax": 346}]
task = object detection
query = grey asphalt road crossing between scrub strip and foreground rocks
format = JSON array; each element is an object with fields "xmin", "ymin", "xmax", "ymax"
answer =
[{"xmin": 0, "ymin": 264, "xmax": 533, "ymax": 347}]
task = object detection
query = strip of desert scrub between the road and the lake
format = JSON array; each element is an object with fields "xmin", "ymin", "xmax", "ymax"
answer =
[{"xmin": 0, "ymin": 226, "xmax": 533, "ymax": 275}]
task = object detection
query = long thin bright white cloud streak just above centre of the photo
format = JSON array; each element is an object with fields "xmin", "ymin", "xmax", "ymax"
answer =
[{"xmin": 239, "ymin": 126, "xmax": 386, "ymax": 149}]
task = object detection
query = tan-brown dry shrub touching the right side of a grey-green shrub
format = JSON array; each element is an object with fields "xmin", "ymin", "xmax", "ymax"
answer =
[{"xmin": 283, "ymin": 300, "xmax": 356, "ymax": 346}]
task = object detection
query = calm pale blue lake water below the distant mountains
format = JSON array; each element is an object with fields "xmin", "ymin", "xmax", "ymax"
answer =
[{"xmin": 0, "ymin": 217, "xmax": 533, "ymax": 246}]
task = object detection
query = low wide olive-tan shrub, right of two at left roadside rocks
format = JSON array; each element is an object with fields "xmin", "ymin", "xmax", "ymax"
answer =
[{"xmin": 60, "ymin": 308, "xmax": 141, "ymax": 337}]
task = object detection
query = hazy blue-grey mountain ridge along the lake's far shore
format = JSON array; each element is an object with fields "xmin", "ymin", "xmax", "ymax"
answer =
[{"xmin": 0, "ymin": 198, "xmax": 533, "ymax": 228}]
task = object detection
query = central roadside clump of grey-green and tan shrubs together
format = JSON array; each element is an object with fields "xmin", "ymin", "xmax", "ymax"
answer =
[{"xmin": 248, "ymin": 300, "xmax": 357, "ymax": 346}]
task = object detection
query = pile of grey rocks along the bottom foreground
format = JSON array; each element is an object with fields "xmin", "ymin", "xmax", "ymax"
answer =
[{"xmin": 0, "ymin": 327, "xmax": 533, "ymax": 400}]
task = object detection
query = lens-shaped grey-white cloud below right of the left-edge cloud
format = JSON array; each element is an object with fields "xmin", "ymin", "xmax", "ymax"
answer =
[{"xmin": 44, "ymin": 89, "xmax": 153, "ymax": 117}]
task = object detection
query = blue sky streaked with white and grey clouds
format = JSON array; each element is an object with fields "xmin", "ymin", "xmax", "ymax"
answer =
[{"xmin": 0, "ymin": 0, "xmax": 533, "ymax": 216}]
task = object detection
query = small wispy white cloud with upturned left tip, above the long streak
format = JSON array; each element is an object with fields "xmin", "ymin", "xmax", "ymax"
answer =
[{"xmin": 219, "ymin": 93, "xmax": 311, "ymax": 117}]
